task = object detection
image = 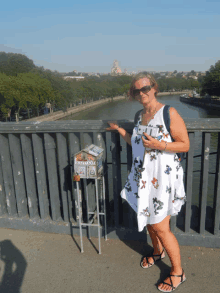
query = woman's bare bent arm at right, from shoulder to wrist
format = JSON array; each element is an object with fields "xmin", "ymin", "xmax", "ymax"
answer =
[{"xmin": 166, "ymin": 107, "xmax": 190, "ymax": 153}]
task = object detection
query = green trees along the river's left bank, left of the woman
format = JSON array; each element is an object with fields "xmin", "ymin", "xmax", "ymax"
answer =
[{"xmin": 0, "ymin": 52, "xmax": 131, "ymax": 118}]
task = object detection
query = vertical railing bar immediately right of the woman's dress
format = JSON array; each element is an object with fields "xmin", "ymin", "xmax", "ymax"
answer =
[{"xmin": 185, "ymin": 132, "xmax": 195, "ymax": 233}]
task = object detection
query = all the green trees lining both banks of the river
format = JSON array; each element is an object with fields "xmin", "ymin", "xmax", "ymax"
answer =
[{"xmin": 0, "ymin": 52, "xmax": 220, "ymax": 118}]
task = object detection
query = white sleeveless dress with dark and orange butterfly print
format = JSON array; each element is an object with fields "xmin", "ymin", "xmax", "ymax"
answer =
[{"xmin": 121, "ymin": 106, "xmax": 186, "ymax": 232}]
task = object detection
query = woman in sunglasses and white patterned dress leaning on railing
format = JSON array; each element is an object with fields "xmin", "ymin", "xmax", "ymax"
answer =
[{"xmin": 107, "ymin": 73, "xmax": 189, "ymax": 292}]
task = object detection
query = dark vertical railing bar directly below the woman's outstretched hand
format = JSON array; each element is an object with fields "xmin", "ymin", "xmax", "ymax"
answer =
[{"xmin": 111, "ymin": 132, "xmax": 122, "ymax": 227}]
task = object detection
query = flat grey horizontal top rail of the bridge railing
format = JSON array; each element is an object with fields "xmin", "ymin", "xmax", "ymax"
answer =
[{"xmin": 0, "ymin": 118, "xmax": 220, "ymax": 133}]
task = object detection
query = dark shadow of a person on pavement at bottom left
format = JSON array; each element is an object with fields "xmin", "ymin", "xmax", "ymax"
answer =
[{"xmin": 0, "ymin": 240, "xmax": 27, "ymax": 293}]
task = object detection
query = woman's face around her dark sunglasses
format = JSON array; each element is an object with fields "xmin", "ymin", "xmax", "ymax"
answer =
[{"xmin": 134, "ymin": 77, "xmax": 156, "ymax": 106}]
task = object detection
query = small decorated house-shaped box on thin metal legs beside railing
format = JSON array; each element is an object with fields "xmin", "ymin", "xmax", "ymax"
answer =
[{"xmin": 73, "ymin": 144, "xmax": 107, "ymax": 254}]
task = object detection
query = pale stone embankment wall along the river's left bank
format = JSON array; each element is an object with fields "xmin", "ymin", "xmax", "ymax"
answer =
[{"xmin": 25, "ymin": 96, "xmax": 125, "ymax": 122}]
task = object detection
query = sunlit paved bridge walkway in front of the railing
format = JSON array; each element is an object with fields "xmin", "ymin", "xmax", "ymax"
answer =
[{"xmin": 0, "ymin": 229, "xmax": 220, "ymax": 293}]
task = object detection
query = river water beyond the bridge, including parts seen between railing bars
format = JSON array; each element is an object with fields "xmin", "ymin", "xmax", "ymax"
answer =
[{"xmin": 62, "ymin": 95, "xmax": 220, "ymax": 207}]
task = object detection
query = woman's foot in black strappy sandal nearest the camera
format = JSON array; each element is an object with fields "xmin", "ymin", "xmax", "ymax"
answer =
[{"xmin": 157, "ymin": 269, "xmax": 186, "ymax": 292}]
